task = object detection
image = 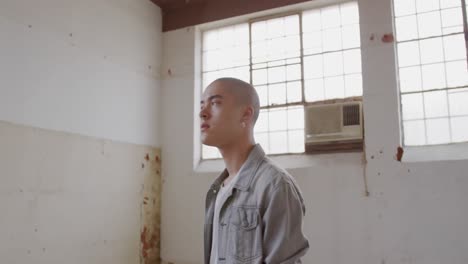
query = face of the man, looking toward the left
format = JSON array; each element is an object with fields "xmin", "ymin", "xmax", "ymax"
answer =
[{"xmin": 200, "ymin": 82, "xmax": 242, "ymax": 147}]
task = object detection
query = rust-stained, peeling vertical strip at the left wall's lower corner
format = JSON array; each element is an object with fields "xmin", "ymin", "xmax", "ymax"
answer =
[{"xmin": 140, "ymin": 150, "xmax": 161, "ymax": 264}]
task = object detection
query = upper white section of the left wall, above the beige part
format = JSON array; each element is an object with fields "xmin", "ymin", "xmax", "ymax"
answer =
[{"xmin": 0, "ymin": 0, "xmax": 162, "ymax": 146}]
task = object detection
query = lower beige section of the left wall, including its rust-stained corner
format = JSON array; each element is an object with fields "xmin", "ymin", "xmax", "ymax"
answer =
[{"xmin": 0, "ymin": 122, "xmax": 161, "ymax": 264}]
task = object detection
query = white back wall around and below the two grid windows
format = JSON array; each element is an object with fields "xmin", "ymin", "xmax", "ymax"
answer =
[{"xmin": 161, "ymin": 0, "xmax": 468, "ymax": 264}]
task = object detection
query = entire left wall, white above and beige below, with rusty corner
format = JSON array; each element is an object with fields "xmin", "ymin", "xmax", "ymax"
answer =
[{"xmin": 0, "ymin": 0, "xmax": 162, "ymax": 264}]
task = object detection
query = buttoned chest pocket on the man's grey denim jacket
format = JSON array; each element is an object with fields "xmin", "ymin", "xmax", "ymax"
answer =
[{"xmin": 229, "ymin": 207, "xmax": 262, "ymax": 263}]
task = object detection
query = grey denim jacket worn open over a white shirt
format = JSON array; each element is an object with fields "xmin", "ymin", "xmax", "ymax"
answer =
[{"xmin": 204, "ymin": 144, "xmax": 309, "ymax": 264}]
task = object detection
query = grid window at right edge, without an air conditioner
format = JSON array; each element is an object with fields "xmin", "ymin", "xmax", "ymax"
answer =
[{"xmin": 393, "ymin": 0, "xmax": 468, "ymax": 146}]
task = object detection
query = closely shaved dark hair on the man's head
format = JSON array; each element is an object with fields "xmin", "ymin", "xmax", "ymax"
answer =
[{"xmin": 210, "ymin": 77, "xmax": 260, "ymax": 125}]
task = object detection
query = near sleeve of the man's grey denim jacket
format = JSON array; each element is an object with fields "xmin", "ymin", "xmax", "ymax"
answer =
[{"xmin": 262, "ymin": 182, "xmax": 309, "ymax": 264}]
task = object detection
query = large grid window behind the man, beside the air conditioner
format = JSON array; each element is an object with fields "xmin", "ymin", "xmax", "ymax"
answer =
[{"xmin": 202, "ymin": 2, "xmax": 362, "ymax": 159}]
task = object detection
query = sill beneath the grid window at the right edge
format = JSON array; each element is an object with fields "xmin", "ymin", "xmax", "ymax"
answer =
[{"xmin": 402, "ymin": 142, "xmax": 468, "ymax": 163}]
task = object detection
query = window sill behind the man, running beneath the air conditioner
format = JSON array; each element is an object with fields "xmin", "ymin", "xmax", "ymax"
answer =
[{"xmin": 195, "ymin": 152, "xmax": 363, "ymax": 173}]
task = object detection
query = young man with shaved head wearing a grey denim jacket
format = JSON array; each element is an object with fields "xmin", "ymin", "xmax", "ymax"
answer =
[{"xmin": 200, "ymin": 78, "xmax": 309, "ymax": 264}]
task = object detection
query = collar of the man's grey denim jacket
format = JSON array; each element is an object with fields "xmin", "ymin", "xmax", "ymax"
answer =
[{"xmin": 211, "ymin": 144, "xmax": 265, "ymax": 191}]
